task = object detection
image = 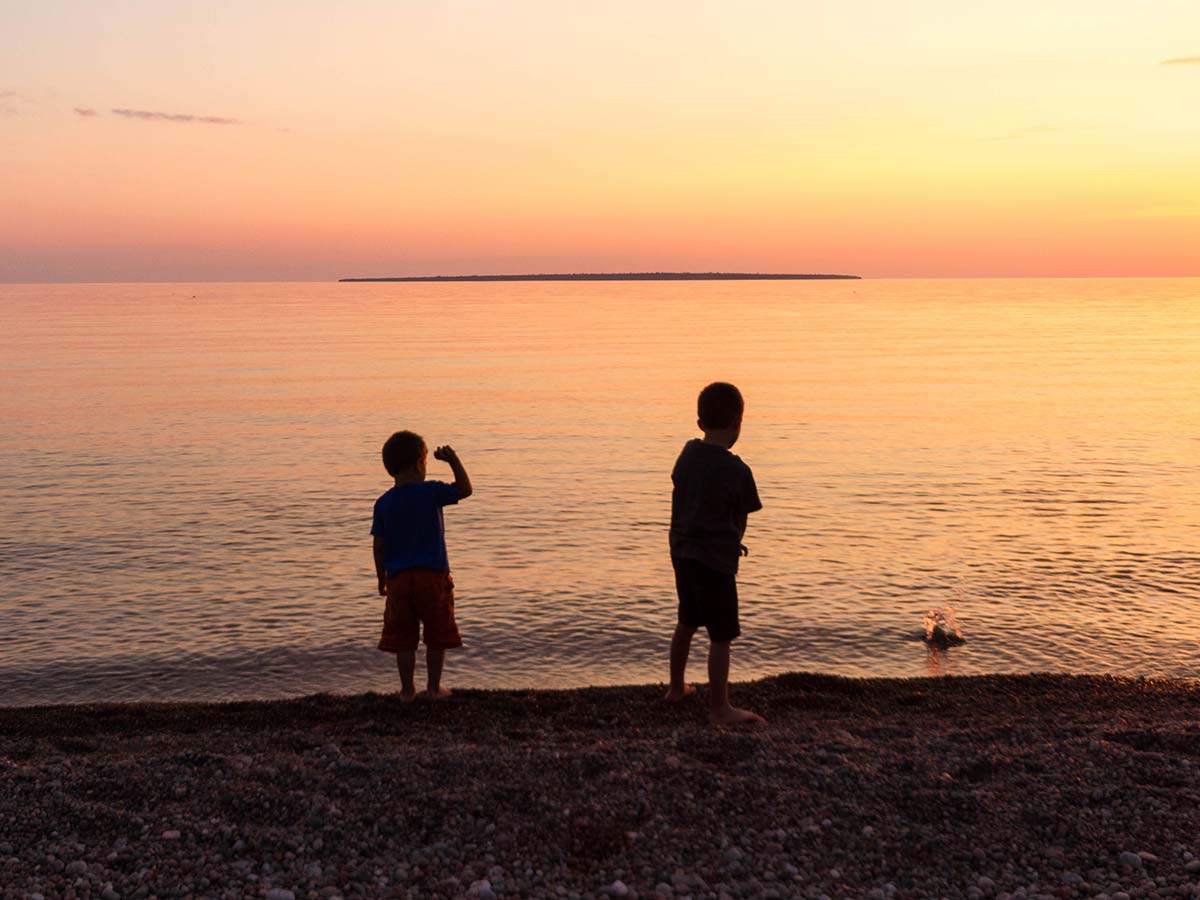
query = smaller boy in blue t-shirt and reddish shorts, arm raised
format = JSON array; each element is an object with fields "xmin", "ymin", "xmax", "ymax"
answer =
[{"xmin": 371, "ymin": 431, "xmax": 472, "ymax": 700}]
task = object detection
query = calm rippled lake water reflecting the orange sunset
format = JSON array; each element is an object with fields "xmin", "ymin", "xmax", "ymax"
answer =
[{"xmin": 0, "ymin": 280, "xmax": 1200, "ymax": 706}]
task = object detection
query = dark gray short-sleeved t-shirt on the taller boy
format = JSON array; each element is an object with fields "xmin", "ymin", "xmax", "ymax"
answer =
[{"xmin": 671, "ymin": 438, "xmax": 762, "ymax": 575}]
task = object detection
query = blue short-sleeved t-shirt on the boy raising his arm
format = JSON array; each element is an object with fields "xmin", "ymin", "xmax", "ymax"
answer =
[{"xmin": 371, "ymin": 481, "xmax": 458, "ymax": 575}]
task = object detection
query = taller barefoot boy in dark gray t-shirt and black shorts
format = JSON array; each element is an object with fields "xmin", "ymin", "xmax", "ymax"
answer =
[{"xmin": 666, "ymin": 382, "xmax": 763, "ymax": 725}]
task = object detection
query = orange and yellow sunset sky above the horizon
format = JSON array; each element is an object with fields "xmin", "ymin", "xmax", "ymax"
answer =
[{"xmin": 0, "ymin": 0, "xmax": 1200, "ymax": 282}]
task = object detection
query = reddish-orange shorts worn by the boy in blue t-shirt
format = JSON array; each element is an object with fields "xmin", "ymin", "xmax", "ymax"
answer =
[{"xmin": 379, "ymin": 569, "xmax": 462, "ymax": 653}]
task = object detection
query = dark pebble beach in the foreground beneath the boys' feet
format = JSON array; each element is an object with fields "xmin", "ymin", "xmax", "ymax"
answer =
[{"xmin": 0, "ymin": 674, "xmax": 1200, "ymax": 900}]
